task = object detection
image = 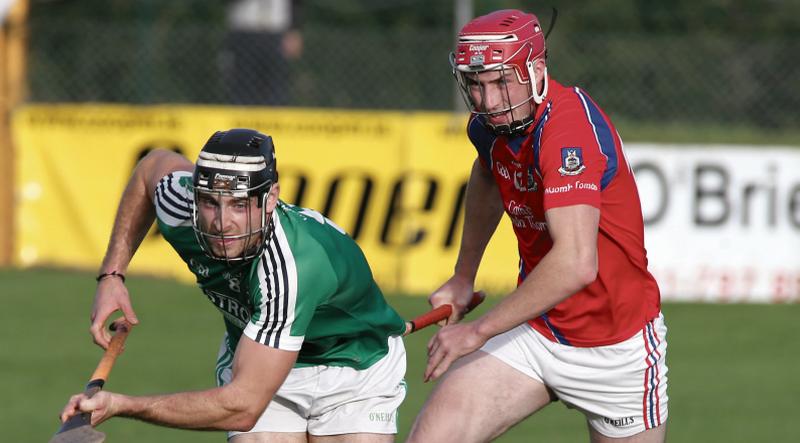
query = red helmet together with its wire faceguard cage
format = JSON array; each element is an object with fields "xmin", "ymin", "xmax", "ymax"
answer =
[{"xmin": 450, "ymin": 9, "xmax": 547, "ymax": 135}]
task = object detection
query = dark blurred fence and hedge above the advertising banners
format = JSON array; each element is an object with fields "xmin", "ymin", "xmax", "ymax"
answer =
[{"xmin": 21, "ymin": 0, "xmax": 800, "ymax": 129}]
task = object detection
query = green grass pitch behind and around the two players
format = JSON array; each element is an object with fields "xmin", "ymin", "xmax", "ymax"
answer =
[{"xmin": 0, "ymin": 270, "xmax": 800, "ymax": 443}]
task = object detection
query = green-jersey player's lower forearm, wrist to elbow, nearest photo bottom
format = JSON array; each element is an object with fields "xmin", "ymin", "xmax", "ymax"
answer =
[{"xmin": 115, "ymin": 388, "xmax": 261, "ymax": 431}]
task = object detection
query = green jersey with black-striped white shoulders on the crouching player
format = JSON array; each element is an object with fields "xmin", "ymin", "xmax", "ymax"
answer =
[{"xmin": 154, "ymin": 171, "xmax": 405, "ymax": 369}]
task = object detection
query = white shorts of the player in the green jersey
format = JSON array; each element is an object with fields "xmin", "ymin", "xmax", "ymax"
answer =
[{"xmin": 217, "ymin": 337, "xmax": 406, "ymax": 439}]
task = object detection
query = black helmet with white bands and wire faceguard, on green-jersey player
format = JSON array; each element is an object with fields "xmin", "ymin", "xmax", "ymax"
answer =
[{"xmin": 192, "ymin": 129, "xmax": 278, "ymax": 263}]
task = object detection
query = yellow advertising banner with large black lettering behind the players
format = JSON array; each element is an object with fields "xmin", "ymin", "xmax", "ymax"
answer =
[{"xmin": 13, "ymin": 105, "xmax": 517, "ymax": 294}]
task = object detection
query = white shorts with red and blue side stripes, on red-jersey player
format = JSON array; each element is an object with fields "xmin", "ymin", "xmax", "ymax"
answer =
[{"xmin": 481, "ymin": 314, "xmax": 668, "ymax": 438}]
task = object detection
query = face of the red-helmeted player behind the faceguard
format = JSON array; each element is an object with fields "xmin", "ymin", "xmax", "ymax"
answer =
[{"xmin": 466, "ymin": 68, "xmax": 534, "ymax": 126}]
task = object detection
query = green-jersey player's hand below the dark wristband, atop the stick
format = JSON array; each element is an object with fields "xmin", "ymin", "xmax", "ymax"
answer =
[{"xmin": 89, "ymin": 277, "xmax": 139, "ymax": 349}]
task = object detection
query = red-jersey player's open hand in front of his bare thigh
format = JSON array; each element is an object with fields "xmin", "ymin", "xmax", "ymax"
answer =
[{"xmin": 424, "ymin": 322, "xmax": 488, "ymax": 382}]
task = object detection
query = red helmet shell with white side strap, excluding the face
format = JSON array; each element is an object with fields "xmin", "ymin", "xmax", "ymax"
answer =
[{"xmin": 450, "ymin": 9, "xmax": 547, "ymax": 132}]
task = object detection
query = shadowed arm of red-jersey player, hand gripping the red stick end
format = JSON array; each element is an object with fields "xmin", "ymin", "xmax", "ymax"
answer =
[{"xmin": 429, "ymin": 159, "xmax": 503, "ymax": 323}]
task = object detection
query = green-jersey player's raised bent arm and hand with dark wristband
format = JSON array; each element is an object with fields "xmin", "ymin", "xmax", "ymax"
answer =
[{"xmin": 89, "ymin": 150, "xmax": 193, "ymax": 349}]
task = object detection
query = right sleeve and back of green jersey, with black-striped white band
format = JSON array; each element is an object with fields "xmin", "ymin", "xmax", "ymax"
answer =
[{"xmin": 246, "ymin": 203, "xmax": 405, "ymax": 368}]
